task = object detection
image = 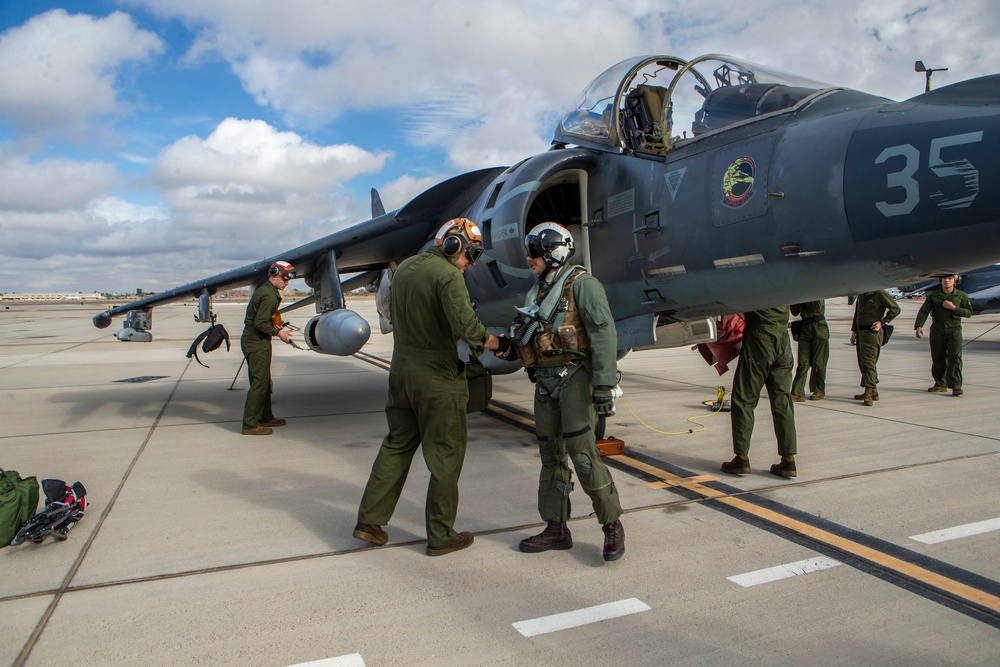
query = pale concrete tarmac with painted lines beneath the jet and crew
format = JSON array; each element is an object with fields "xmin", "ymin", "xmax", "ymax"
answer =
[{"xmin": 0, "ymin": 298, "xmax": 1000, "ymax": 667}]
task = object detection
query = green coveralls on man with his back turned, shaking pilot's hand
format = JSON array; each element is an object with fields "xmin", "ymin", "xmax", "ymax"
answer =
[{"xmin": 358, "ymin": 247, "xmax": 490, "ymax": 547}]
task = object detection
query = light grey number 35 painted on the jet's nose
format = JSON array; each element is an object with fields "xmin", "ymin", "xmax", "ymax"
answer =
[{"xmin": 875, "ymin": 130, "xmax": 983, "ymax": 218}]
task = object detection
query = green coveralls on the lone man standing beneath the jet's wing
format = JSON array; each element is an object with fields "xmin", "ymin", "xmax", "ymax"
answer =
[{"xmin": 240, "ymin": 280, "xmax": 281, "ymax": 428}]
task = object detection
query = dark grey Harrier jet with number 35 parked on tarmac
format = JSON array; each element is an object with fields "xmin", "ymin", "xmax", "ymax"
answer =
[{"xmin": 94, "ymin": 55, "xmax": 1000, "ymax": 370}]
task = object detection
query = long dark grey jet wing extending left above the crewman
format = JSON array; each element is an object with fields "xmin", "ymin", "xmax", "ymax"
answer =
[{"xmin": 94, "ymin": 167, "xmax": 504, "ymax": 340}]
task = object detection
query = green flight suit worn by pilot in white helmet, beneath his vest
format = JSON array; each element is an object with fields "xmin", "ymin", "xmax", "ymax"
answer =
[{"xmin": 525, "ymin": 265, "xmax": 622, "ymax": 525}]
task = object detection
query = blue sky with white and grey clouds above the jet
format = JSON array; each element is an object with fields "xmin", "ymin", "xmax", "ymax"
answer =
[{"xmin": 0, "ymin": 0, "xmax": 1000, "ymax": 293}]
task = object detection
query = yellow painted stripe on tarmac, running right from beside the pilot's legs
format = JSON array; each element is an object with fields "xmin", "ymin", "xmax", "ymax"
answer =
[{"xmin": 610, "ymin": 454, "xmax": 1000, "ymax": 612}]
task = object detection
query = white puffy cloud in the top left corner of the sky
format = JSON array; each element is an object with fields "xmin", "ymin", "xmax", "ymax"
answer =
[{"xmin": 0, "ymin": 9, "xmax": 163, "ymax": 134}]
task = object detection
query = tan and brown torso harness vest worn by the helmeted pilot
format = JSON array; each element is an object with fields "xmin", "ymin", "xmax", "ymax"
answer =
[{"xmin": 510, "ymin": 266, "xmax": 590, "ymax": 369}]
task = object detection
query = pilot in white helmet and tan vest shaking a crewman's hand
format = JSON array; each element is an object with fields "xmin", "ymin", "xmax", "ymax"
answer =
[{"xmin": 497, "ymin": 222, "xmax": 625, "ymax": 561}]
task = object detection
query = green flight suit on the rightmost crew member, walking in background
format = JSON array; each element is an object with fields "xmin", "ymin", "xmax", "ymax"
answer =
[{"xmin": 913, "ymin": 289, "xmax": 972, "ymax": 389}]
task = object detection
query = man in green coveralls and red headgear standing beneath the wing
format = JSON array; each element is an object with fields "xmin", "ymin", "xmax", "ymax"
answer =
[{"xmin": 240, "ymin": 262, "xmax": 295, "ymax": 435}]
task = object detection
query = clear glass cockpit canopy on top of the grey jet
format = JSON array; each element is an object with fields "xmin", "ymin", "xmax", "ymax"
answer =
[{"xmin": 553, "ymin": 54, "xmax": 832, "ymax": 155}]
